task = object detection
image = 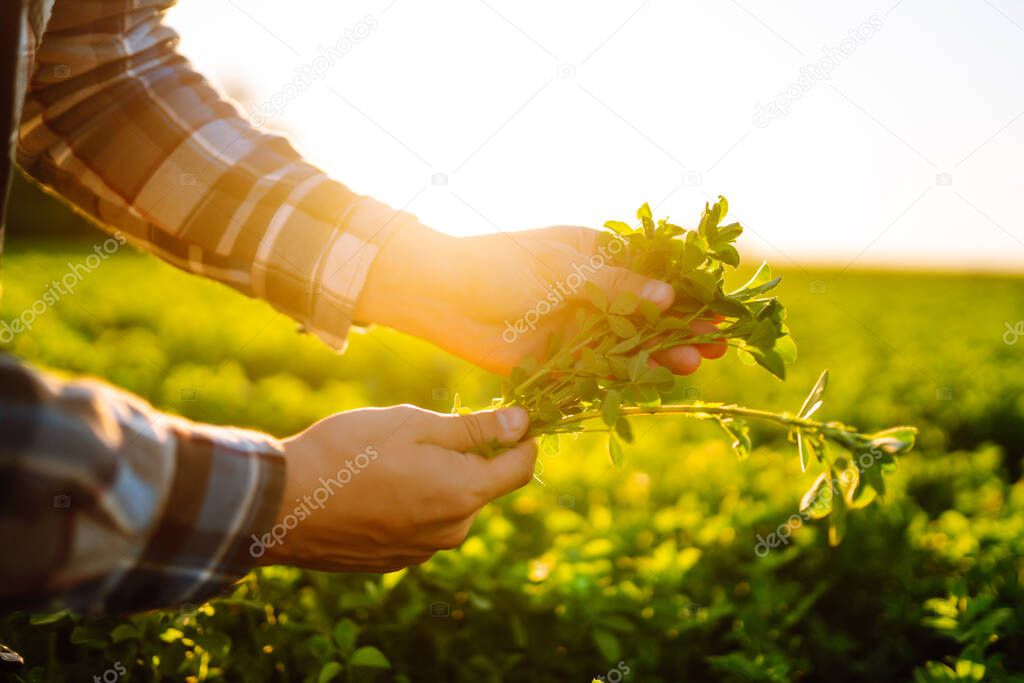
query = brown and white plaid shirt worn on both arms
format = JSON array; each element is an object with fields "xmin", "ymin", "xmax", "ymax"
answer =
[{"xmin": 0, "ymin": 0, "xmax": 415, "ymax": 612}]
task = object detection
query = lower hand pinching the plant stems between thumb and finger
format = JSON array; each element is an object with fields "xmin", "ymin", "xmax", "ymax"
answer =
[{"xmin": 256, "ymin": 405, "xmax": 537, "ymax": 572}]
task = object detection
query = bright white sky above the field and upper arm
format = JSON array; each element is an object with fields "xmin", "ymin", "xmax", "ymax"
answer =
[{"xmin": 169, "ymin": 0, "xmax": 1024, "ymax": 270}]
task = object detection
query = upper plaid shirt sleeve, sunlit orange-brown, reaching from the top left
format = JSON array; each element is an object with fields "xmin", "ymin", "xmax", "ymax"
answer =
[{"xmin": 17, "ymin": 0, "xmax": 416, "ymax": 349}]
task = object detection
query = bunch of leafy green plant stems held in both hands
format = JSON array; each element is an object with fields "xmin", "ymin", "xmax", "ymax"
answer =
[{"xmin": 501, "ymin": 197, "xmax": 916, "ymax": 544}]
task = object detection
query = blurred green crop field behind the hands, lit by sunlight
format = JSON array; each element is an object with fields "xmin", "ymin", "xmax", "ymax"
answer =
[{"xmin": 0, "ymin": 223, "xmax": 1024, "ymax": 683}]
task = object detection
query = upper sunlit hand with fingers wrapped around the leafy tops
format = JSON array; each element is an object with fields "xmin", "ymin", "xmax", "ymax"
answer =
[{"xmin": 356, "ymin": 224, "xmax": 725, "ymax": 375}]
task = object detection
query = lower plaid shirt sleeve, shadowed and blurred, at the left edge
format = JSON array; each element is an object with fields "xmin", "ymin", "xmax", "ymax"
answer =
[{"xmin": 0, "ymin": 356, "xmax": 285, "ymax": 614}]
